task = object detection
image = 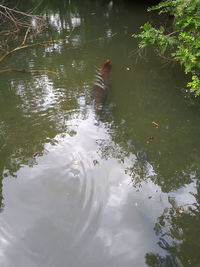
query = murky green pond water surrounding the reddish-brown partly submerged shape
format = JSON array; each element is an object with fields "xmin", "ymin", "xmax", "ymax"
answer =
[{"xmin": 0, "ymin": 1, "xmax": 200, "ymax": 267}]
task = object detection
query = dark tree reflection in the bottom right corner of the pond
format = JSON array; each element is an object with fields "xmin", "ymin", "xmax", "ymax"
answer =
[{"xmin": 146, "ymin": 184, "xmax": 200, "ymax": 267}]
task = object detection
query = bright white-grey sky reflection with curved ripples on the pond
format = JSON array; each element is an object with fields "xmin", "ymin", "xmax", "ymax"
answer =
[{"xmin": 0, "ymin": 112, "xmax": 168, "ymax": 267}]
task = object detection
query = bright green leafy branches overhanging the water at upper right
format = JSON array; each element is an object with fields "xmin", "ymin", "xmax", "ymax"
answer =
[{"xmin": 133, "ymin": 0, "xmax": 200, "ymax": 96}]
